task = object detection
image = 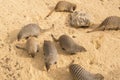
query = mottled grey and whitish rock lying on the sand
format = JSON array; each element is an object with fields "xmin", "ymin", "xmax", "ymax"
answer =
[{"xmin": 70, "ymin": 11, "xmax": 92, "ymax": 28}]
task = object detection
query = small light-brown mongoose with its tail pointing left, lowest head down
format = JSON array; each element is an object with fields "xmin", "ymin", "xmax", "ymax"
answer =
[{"xmin": 16, "ymin": 37, "xmax": 39, "ymax": 58}]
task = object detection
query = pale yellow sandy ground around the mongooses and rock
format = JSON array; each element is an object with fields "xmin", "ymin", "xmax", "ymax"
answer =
[{"xmin": 0, "ymin": 0, "xmax": 120, "ymax": 80}]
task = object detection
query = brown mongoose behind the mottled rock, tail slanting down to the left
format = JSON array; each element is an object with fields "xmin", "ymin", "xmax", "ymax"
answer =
[{"xmin": 45, "ymin": 1, "xmax": 76, "ymax": 19}]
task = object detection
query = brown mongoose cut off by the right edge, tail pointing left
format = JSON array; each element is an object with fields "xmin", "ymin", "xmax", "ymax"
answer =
[{"xmin": 87, "ymin": 16, "xmax": 120, "ymax": 33}]
